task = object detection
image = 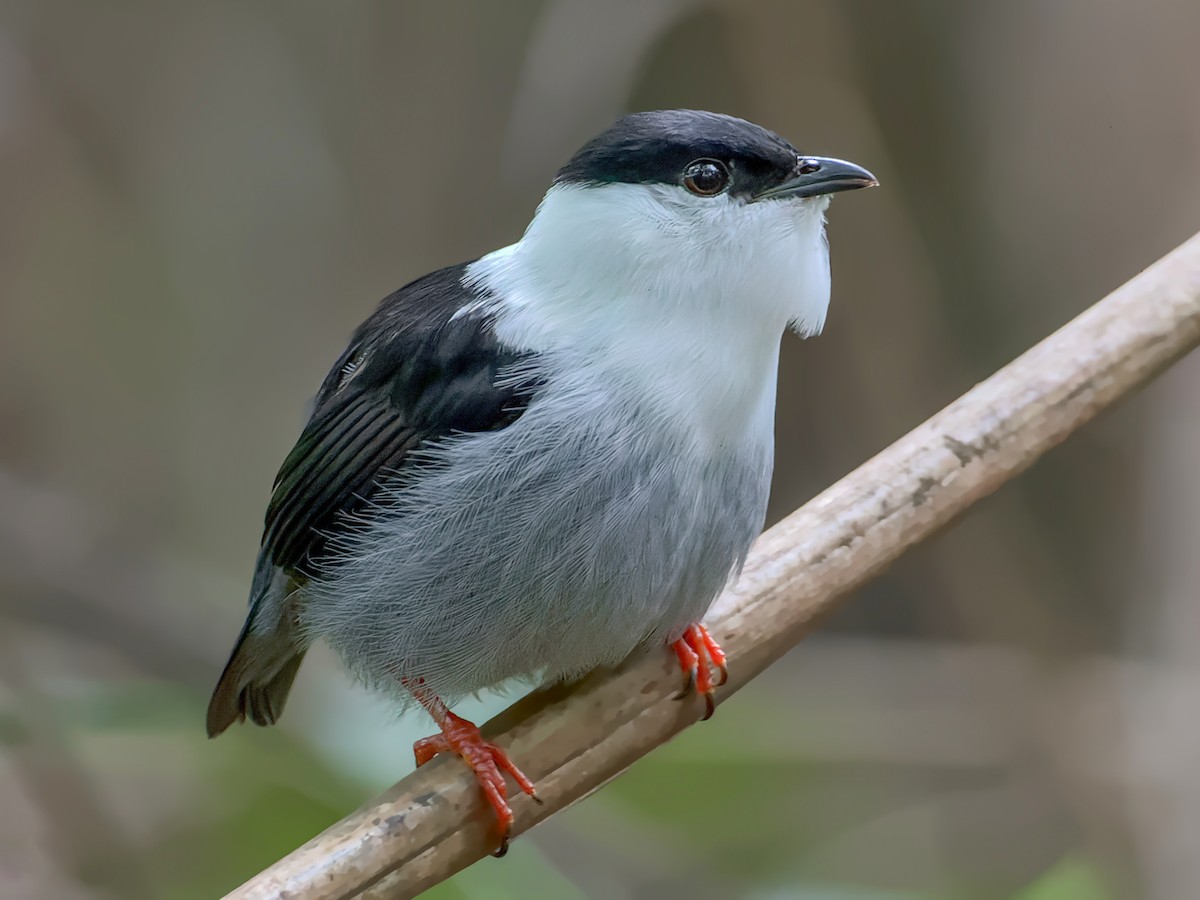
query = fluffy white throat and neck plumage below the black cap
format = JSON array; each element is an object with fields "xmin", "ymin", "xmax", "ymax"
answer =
[{"xmin": 468, "ymin": 184, "xmax": 829, "ymax": 445}]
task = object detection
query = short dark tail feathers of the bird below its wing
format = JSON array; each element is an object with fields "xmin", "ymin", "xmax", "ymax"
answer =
[{"xmin": 208, "ymin": 622, "xmax": 305, "ymax": 738}]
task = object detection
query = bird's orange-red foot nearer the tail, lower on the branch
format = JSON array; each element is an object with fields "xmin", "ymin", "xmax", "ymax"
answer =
[{"xmin": 413, "ymin": 689, "xmax": 541, "ymax": 857}]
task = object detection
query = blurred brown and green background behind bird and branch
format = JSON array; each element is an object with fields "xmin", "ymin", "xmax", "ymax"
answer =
[{"xmin": 0, "ymin": 0, "xmax": 1200, "ymax": 900}]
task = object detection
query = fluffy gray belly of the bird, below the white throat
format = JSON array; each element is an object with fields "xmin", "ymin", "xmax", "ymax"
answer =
[{"xmin": 300, "ymin": 406, "xmax": 772, "ymax": 700}]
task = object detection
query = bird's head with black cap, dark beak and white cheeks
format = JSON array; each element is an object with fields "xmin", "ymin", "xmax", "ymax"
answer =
[{"xmin": 472, "ymin": 109, "xmax": 876, "ymax": 352}]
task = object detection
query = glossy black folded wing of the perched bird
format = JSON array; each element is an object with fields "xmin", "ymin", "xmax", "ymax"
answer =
[{"xmin": 259, "ymin": 264, "xmax": 529, "ymax": 574}]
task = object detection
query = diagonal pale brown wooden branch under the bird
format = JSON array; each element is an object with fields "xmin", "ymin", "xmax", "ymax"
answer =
[{"xmin": 228, "ymin": 235, "xmax": 1200, "ymax": 900}]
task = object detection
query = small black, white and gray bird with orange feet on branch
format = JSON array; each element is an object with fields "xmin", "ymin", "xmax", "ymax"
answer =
[{"xmin": 208, "ymin": 109, "xmax": 877, "ymax": 854}]
